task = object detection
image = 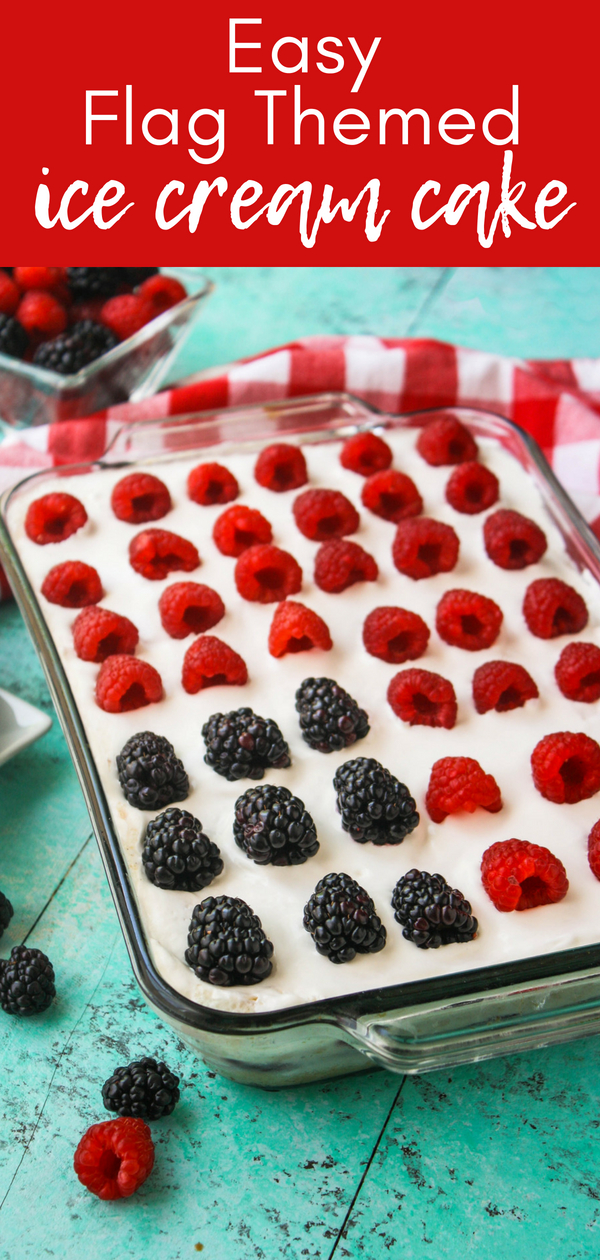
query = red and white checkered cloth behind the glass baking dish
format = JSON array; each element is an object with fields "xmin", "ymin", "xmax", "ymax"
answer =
[{"xmin": 0, "ymin": 336, "xmax": 600, "ymax": 592}]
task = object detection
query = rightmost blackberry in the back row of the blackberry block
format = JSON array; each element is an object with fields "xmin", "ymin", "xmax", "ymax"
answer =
[{"xmin": 296, "ymin": 678, "xmax": 369, "ymax": 752}]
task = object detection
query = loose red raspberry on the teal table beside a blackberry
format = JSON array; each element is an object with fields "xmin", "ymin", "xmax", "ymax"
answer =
[{"xmin": 73, "ymin": 1115, "xmax": 154, "ymax": 1200}]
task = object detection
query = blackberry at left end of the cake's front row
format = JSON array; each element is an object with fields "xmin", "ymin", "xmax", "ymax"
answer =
[{"xmin": 185, "ymin": 897, "xmax": 274, "ymax": 987}]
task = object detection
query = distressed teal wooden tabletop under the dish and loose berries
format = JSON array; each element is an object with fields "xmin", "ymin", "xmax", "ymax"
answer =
[{"xmin": 0, "ymin": 268, "xmax": 600, "ymax": 1260}]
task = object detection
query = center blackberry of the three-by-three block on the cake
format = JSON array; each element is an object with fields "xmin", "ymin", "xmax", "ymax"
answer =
[{"xmin": 233, "ymin": 784, "xmax": 319, "ymax": 866}]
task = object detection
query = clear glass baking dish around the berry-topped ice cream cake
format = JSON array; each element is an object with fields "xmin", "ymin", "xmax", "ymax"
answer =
[{"xmin": 0, "ymin": 394, "xmax": 600, "ymax": 1089}]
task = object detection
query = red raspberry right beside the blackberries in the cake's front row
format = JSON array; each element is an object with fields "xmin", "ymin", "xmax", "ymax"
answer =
[{"xmin": 482, "ymin": 839, "xmax": 568, "ymax": 911}]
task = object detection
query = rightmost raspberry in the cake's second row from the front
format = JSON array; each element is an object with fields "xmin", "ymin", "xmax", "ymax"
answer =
[{"xmin": 531, "ymin": 731, "xmax": 600, "ymax": 805}]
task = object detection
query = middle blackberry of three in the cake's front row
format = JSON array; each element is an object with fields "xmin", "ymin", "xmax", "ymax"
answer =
[{"xmin": 304, "ymin": 874, "xmax": 387, "ymax": 963}]
